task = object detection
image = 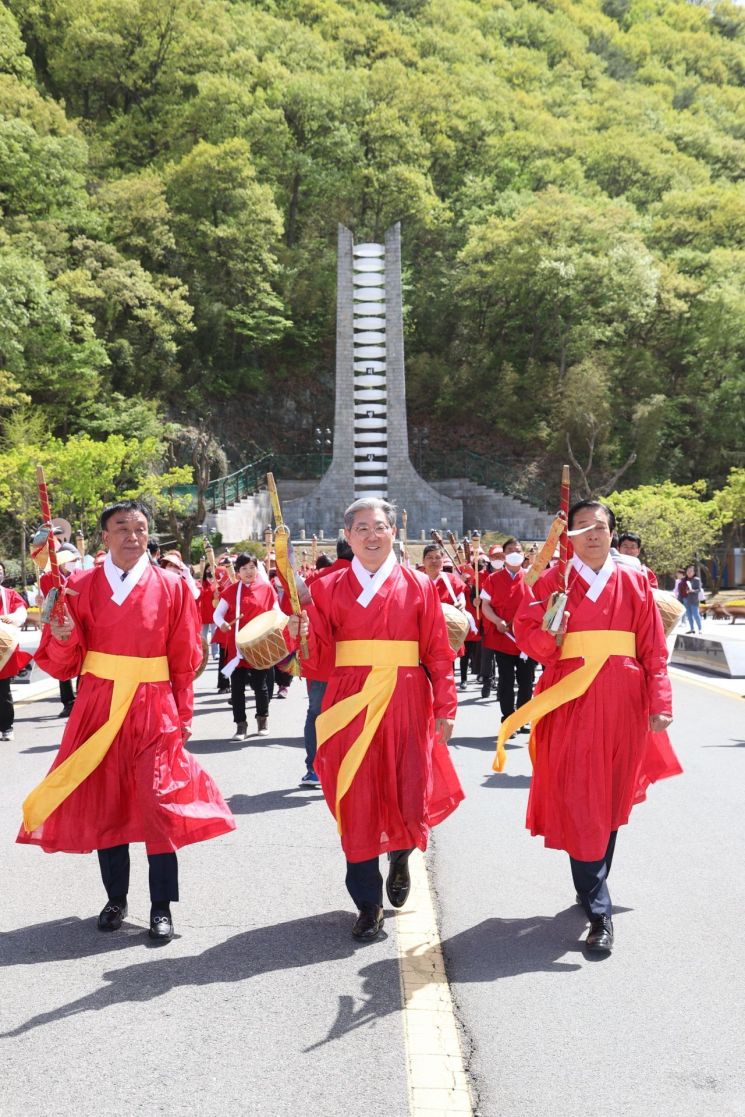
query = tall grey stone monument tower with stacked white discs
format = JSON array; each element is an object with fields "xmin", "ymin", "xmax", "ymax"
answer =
[{"xmin": 285, "ymin": 222, "xmax": 464, "ymax": 538}]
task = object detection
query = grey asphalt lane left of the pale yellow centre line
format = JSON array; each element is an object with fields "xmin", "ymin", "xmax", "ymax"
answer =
[{"xmin": 0, "ymin": 666, "xmax": 409, "ymax": 1117}]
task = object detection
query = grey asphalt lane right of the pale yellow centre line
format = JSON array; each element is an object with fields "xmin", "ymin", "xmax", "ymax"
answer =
[{"xmin": 433, "ymin": 678, "xmax": 745, "ymax": 1117}]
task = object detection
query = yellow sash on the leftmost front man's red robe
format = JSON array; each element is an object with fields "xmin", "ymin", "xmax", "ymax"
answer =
[{"xmin": 23, "ymin": 651, "xmax": 170, "ymax": 833}]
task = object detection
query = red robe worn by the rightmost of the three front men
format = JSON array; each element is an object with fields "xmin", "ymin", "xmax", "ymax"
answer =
[{"xmin": 514, "ymin": 560, "xmax": 682, "ymax": 861}]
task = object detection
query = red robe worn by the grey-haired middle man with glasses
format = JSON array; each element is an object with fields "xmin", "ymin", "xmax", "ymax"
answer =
[{"xmin": 309, "ymin": 565, "xmax": 464, "ymax": 861}]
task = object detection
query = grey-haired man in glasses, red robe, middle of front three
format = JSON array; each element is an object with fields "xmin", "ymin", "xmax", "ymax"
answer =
[{"xmin": 289, "ymin": 497, "xmax": 464, "ymax": 939}]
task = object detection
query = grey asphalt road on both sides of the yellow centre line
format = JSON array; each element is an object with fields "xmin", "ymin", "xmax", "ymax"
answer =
[{"xmin": 0, "ymin": 647, "xmax": 745, "ymax": 1117}]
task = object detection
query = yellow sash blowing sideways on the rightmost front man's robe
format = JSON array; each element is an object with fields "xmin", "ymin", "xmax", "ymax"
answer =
[{"xmin": 491, "ymin": 630, "xmax": 637, "ymax": 772}]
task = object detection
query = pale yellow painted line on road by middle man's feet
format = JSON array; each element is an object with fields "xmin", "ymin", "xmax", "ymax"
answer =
[{"xmin": 395, "ymin": 850, "xmax": 474, "ymax": 1117}]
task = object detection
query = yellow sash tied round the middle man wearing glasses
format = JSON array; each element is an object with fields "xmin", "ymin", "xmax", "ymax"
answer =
[{"xmin": 316, "ymin": 640, "xmax": 419, "ymax": 834}]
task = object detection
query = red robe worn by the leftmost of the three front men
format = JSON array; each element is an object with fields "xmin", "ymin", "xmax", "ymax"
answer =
[{"xmin": 18, "ymin": 565, "xmax": 236, "ymax": 853}]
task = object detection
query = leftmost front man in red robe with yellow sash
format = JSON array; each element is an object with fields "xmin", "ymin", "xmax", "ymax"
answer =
[{"xmin": 18, "ymin": 500, "xmax": 236, "ymax": 942}]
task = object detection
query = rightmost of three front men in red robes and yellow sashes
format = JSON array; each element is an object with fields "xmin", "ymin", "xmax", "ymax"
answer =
[{"xmin": 496, "ymin": 500, "xmax": 681, "ymax": 953}]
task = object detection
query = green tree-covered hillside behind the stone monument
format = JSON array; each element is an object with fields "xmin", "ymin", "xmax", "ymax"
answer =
[{"xmin": 0, "ymin": 0, "xmax": 745, "ymax": 486}]
